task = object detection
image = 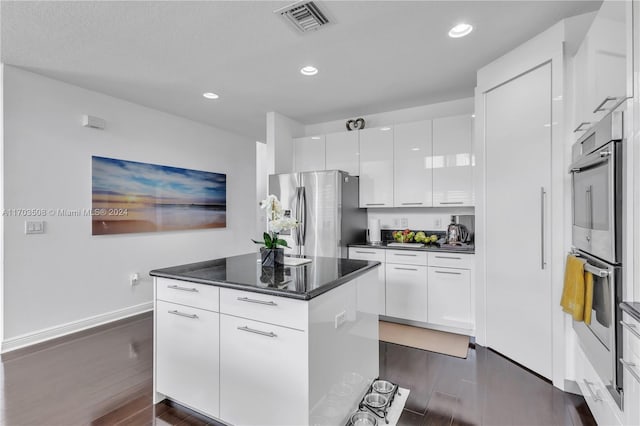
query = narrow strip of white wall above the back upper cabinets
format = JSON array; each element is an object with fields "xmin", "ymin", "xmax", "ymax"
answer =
[{"xmin": 303, "ymin": 98, "xmax": 474, "ymax": 136}]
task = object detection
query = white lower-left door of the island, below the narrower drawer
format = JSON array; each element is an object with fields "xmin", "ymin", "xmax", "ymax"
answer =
[{"xmin": 156, "ymin": 301, "xmax": 220, "ymax": 417}]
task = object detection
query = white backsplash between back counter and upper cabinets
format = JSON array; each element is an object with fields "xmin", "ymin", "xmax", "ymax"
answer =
[{"xmin": 367, "ymin": 207, "xmax": 475, "ymax": 231}]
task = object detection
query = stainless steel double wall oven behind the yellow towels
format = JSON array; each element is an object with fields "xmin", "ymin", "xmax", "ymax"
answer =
[{"xmin": 569, "ymin": 111, "xmax": 623, "ymax": 405}]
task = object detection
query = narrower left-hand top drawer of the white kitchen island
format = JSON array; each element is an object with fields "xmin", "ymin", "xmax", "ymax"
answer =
[{"xmin": 156, "ymin": 278, "xmax": 220, "ymax": 312}]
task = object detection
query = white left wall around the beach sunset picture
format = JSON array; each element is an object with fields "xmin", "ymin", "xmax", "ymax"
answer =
[{"xmin": 3, "ymin": 66, "xmax": 256, "ymax": 350}]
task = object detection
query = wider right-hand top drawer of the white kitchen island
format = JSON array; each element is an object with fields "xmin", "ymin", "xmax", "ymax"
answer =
[{"xmin": 220, "ymin": 288, "xmax": 308, "ymax": 331}]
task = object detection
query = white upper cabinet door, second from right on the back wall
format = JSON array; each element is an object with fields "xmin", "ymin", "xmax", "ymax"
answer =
[{"xmin": 393, "ymin": 120, "xmax": 433, "ymax": 207}]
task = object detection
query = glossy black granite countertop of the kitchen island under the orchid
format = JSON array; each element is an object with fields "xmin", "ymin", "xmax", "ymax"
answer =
[{"xmin": 149, "ymin": 253, "xmax": 380, "ymax": 300}]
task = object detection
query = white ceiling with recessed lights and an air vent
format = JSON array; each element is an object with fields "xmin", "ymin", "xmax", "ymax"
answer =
[{"xmin": 1, "ymin": 0, "xmax": 601, "ymax": 140}]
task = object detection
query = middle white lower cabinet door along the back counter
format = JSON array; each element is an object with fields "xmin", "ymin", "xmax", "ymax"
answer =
[{"xmin": 386, "ymin": 263, "xmax": 427, "ymax": 322}]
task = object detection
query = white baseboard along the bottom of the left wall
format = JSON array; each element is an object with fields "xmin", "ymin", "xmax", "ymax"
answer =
[{"xmin": 0, "ymin": 302, "xmax": 153, "ymax": 353}]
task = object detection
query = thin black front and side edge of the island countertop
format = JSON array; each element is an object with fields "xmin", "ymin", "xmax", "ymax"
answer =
[{"xmin": 149, "ymin": 261, "xmax": 381, "ymax": 300}]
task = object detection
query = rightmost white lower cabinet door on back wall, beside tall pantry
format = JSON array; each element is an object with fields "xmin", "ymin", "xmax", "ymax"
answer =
[{"xmin": 427, "ymin": 267, "xmax": 473, "ymax": 329}]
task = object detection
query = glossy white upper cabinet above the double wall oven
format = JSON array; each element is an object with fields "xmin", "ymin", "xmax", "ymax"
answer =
[{"xmin": 573, "ymin": 0, "xmax": 633, "ymax": 138}]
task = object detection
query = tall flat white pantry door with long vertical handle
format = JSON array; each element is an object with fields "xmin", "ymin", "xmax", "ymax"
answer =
[{"xmin": 485, "ymin": 64, "xmax": 559, "ymax": 378}]
